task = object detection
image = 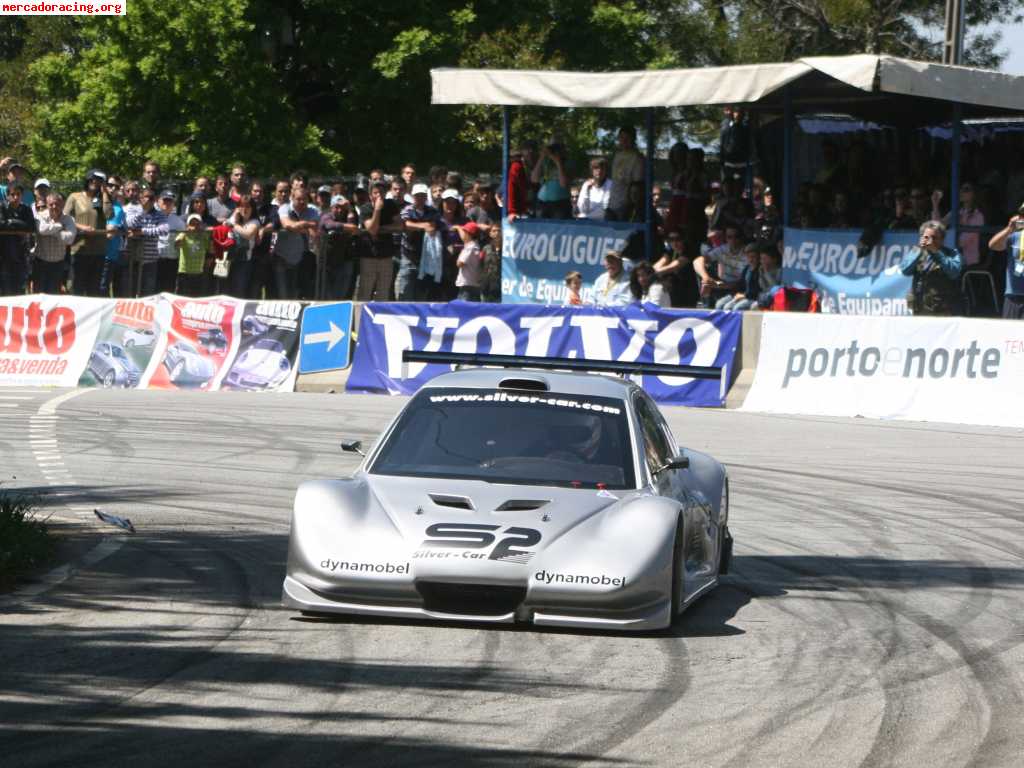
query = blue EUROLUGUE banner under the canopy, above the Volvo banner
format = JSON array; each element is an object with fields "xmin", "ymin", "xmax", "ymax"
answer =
[{"xmin": 502, "ymin": 219, "xmax": 643, "ymax": 304}]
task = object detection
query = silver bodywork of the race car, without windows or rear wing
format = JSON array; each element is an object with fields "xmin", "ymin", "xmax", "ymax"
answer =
[{"xmin": 283, "ymin": 370, "xmax": 728, "ymax": 631}]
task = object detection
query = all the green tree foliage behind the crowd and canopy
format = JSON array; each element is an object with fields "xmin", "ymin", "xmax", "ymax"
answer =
[{"xmin": 0, "ymin": 0, "xmax": 1024, "ymax": 178}]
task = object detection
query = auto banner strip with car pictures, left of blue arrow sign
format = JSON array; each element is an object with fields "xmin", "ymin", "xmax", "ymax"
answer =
[{"xmin": 0, "ymin": 294, "xmax": 302, "ymax": 391}]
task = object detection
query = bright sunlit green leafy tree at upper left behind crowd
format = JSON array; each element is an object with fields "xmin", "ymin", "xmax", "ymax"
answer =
[{"xmin": 29, "ymin": 0, "xmax": 339, "ymax": 177}]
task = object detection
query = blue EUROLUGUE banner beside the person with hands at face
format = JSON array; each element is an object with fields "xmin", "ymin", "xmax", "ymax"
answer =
[{"xmin": 782, "ymin": 227, "xmax": 918, "ymax": 315}]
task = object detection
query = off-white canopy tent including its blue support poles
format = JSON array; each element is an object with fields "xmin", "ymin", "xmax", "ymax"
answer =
[{"xmin": 430, "ymin": 53, "xmax": 1024, "ymax": 255}]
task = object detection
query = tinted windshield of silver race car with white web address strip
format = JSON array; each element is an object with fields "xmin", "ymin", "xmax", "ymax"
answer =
[{"xmin": 370, "ymin": 389, "xmax": 635, "ymax": 488}]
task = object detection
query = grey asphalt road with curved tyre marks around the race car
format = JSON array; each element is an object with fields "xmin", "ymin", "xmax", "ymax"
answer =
[{"xmin": 0, "ymin": 390, "xmax": 1024, "ymax": 768}]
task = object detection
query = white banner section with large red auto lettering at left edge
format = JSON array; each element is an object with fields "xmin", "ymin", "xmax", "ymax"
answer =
[{"xmin": 0, "ymin": 294, "xmax": 111, "ymax": 387}]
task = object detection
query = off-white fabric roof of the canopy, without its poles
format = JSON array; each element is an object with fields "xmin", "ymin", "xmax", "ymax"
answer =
[{"xmin": 430, "ymin": 54, "xmax": 1024, "ymax": 117}]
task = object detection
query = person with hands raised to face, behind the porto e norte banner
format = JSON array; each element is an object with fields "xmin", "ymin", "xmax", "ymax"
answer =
[{"xmin": 899, "ymin": 221, "xmax": 964, "ymax": 315}]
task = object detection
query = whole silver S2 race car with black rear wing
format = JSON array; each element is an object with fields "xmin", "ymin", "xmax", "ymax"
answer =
[{"xmin": 284, "ymin": 352, "xmax": 732, "ymax": 630}]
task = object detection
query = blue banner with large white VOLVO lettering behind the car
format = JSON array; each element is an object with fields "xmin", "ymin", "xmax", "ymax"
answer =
[{"xmin": 345, "ymin": 301, "xmax": 740, "ymax": 406}]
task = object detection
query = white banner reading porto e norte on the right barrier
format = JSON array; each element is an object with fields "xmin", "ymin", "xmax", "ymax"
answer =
[{"xmin": 743, "ymin": 312, "xmax": 1024, "ymax": 434}]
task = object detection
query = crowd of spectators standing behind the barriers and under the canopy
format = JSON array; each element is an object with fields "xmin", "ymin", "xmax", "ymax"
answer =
[{"xmin": 0, "ymin": 116, "xmax": 1024, "ymax": 312}]
